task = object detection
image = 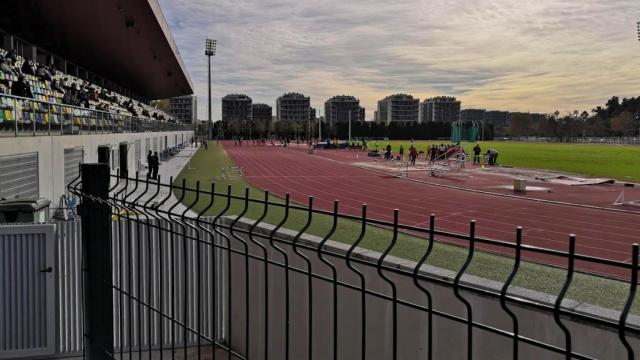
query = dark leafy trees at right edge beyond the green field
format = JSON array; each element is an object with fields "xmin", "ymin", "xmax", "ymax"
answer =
[{"xmin": 508, "ymin": 96, "xmax": 640, "ymax": 141}]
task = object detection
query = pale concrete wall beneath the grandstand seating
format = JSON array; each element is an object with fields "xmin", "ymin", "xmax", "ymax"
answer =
[{"xmin": 0, "ymin": 131, "xmax": 193, "ymax": 206}]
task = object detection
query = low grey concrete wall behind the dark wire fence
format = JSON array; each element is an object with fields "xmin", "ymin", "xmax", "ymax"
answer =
[{"xmin": 219, "ymin": 219, "xmax": 640, "ymax": 360}]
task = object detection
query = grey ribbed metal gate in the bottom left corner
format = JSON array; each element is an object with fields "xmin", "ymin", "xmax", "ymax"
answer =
[{"xmin": 0, "ymin": 225, "xmax": 56, "ymax": 359}]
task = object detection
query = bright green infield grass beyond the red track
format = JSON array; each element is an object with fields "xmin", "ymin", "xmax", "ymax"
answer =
[{"xmin": 369, "ymin": 140, "xmax": 640, "ymax": 181}]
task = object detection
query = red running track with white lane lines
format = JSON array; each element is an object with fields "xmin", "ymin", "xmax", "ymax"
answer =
[{"xmin": 225, "ymin": 143, "xmax": 640, "ymax": 277}]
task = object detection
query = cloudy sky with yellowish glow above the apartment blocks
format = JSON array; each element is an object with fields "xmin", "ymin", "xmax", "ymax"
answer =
[{"xmin": 160, "ymin": 0, "xmax": 640, "ymax": 120}]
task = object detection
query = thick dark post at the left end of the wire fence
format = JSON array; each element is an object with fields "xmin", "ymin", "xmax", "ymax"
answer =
[{"xmin": 79, "ymin": 164, "xmax": 113, "ymax": 360}]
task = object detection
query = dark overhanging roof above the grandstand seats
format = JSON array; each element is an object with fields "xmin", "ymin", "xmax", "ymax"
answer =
[{"xmin": 0, "ymin": 0, "xmax": 193, "ymax": 99}]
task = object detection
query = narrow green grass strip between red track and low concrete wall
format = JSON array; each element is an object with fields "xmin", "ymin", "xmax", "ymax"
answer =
[{"xmin": 175, "ymin": 142, "xmax": 640, "ymax": 314}]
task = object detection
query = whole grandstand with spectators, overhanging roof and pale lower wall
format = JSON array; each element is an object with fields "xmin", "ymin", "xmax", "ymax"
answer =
[{"xmin": 0, "ymin": 0, "xmax": 193, "ymax": 205}]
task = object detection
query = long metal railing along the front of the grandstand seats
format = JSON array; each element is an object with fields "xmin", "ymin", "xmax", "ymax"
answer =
[{"xmin": 0, "ymin": 94, "xmax": 193, "ymax": 136}]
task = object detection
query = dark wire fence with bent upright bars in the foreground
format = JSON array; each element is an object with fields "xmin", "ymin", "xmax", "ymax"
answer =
[{"xmin": 69, "ymin": 164, "xmax": 640, "ymax": 359}]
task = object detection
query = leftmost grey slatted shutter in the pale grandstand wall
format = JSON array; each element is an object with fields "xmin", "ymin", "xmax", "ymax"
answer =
[{"xmin": 0, "ymin": 153, "xmax": 39, "ymax": 199}]
